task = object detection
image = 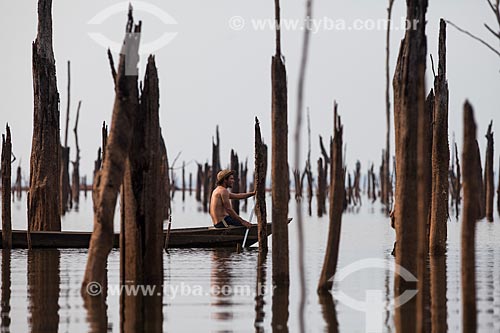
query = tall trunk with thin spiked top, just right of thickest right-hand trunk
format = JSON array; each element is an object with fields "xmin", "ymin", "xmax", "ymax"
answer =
[{"xmin": 430, "ymin": 19, "xmax": 450, "ymax": 255}]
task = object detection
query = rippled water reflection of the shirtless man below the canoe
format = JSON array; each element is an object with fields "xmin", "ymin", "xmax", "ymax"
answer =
[{"xmin": 210, "ymin": 249, "xmax": 233, "ymax": 321}]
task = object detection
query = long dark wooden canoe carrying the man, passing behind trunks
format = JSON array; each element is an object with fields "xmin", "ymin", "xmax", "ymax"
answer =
[{"xmin": 0, "ymin": 219, "xmax": 291, "ymax": 248}]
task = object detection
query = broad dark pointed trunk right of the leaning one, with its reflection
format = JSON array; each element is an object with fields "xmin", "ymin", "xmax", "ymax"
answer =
[{"xmin": 120, "ymin": 56, "xmax": 163, "ymax": 332}]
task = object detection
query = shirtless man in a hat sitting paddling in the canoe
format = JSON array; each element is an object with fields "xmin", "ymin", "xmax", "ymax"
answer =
[{"xmin": 210, "ymin": 169, "xmax": 255, "ymax": 228}]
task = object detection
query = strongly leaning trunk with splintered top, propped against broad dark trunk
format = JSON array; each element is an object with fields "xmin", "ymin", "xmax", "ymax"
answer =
[{"xmin": 82, "ymin": 11, "xmax": 141, "ymax": 298}]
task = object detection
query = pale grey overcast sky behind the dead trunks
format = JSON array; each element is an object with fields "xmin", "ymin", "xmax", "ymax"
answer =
[{"xmin": 0, "ymin": 0, "xmax": 500, "ymax": 181}]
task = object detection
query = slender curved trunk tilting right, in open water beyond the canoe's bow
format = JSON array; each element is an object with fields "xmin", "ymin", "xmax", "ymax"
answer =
[{"xmin": 317, "ymin": 108, "xmax": 345, "ymax": 294}]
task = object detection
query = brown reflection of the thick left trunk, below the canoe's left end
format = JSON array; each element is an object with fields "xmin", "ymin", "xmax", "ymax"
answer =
[{"xmin": 28, "ymin": 249, "xmax": 60, "ymax": 332}]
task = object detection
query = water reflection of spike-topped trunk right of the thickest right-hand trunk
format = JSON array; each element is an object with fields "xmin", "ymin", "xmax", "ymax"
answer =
[{"xmin": 430, "ymin": 255, "xmax": 448, "ymax": 333}]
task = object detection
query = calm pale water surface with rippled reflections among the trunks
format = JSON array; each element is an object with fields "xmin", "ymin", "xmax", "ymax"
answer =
[{"xmin": 1, "ymin": 194, "xmax": 500, "ymax": 333}]
